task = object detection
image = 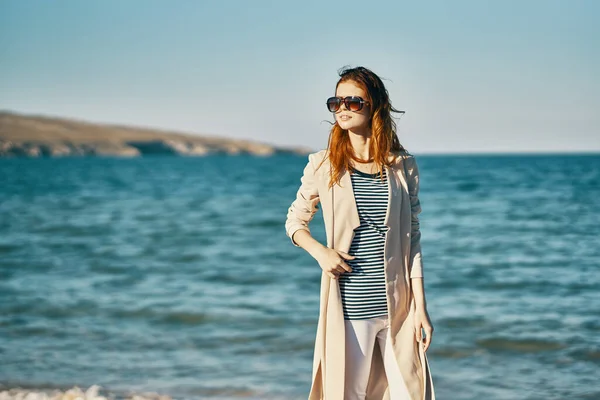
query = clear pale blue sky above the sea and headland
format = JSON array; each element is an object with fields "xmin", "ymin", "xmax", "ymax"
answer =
[{"xmin": 0, "ymin": 0, "xmax": 600, "ymax": 154}]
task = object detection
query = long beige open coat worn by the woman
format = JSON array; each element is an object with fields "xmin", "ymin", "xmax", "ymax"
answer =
[{"xmin": 285, "ymin": 150, "xmax": 435, "ymax": 400}]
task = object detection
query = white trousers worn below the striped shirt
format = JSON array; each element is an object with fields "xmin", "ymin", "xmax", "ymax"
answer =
[{"xmin": 344, "ymin": 316, "xmax": 410, "ymax": 400}]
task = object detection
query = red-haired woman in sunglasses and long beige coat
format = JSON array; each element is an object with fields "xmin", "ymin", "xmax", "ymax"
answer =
[{"xmin": 285, "ymin": 67, "xmax": 435, "ymax": 400}]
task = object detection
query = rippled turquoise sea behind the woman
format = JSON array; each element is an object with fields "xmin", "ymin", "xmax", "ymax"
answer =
[{"xmin": 0, "ymin": 154, "xmax": 600, "ymax": 400}]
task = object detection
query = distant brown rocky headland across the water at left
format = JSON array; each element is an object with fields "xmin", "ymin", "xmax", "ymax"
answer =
[{"xmin": 0, "ymin": 111, "xmax": 314, "ymax": 157}]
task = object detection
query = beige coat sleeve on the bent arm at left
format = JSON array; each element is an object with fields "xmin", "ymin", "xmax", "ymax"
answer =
[{"xmin": 285, "ymin": 153, "xmax": 320, "ymax": 247}]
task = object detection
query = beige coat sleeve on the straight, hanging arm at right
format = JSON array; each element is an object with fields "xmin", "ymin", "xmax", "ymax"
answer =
[{"xmin": 406, "ymin": 156, "xmax": 423, "ymax": 278}]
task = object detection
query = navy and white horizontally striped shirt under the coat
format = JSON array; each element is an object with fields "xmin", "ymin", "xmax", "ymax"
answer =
[{"xmin": 339, "ymin": 169, "xmax": 389, "ymax": 320}]
